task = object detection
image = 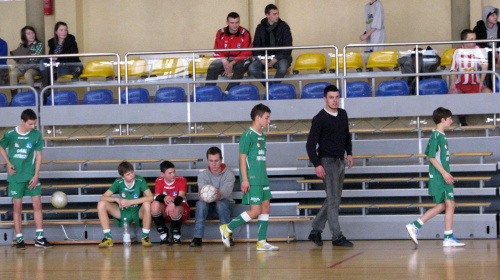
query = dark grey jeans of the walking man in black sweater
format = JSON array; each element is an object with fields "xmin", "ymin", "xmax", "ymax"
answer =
[{"xmin": 311, "ymin": 158, "xmax": 345, "ymax": 240}]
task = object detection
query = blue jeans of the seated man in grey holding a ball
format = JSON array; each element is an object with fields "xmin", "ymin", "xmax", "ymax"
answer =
[{"xmin": 194, "ymin": 199, "xmax": 234, "ymax": 238}]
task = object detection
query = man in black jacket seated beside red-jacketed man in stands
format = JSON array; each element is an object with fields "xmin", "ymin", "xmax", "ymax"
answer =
[{"xmin": 248, "ymin": 4, "xmax": 292, "ymax": 86}]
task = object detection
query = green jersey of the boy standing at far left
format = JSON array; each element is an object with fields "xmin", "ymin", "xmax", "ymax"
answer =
[{"xmin": 0, "ymin": 127, "xmax": 43, "ymax": 182}]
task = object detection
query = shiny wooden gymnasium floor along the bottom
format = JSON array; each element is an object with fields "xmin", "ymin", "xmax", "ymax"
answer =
[{"xmin": 0, "ymin": 239, "xmax": 500, "ymax": 280}]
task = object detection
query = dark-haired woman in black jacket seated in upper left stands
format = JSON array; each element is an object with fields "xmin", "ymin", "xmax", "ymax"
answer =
[{"xmin": 42, "ymin": 21, "xmax": 83, "ymax": 86}]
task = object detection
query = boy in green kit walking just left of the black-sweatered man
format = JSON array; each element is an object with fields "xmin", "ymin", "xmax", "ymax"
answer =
[{"xmin": 220, "ymin": 103, "xmax": 279, "ymax": 251}]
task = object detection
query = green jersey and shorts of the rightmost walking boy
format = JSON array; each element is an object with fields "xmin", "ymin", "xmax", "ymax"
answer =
[{"xmin": 425, "ymin": 130, "xmax": 452, "ymax": 195}]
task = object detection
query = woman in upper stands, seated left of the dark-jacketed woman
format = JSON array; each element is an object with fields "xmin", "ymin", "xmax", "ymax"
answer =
[{"xmin": 9, "ymin": 26, "xmax": 43, "ymax": 97}]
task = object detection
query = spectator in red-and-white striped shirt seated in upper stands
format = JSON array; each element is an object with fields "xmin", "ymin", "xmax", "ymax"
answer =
[{"xmin": 449, "ymin": 29, "xmax": 491, "ymax": 126}]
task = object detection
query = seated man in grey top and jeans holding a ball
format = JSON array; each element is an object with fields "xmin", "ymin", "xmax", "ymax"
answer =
[{"xmin": 189, "ymin": 147, "xmax": 235, "ymax": 247}]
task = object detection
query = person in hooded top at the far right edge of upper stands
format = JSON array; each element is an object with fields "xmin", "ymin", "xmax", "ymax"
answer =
[{"xmin": 474, "ymin": 6, "xmax": 500, "ymax": 88}]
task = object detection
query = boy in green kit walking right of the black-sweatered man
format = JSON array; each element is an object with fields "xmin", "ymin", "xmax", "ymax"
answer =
[{"xmin": 406, "ymin": 107, "xmax": 465, "ymax": 247}]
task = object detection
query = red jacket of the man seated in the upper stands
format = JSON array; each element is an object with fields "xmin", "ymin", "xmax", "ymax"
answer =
[{"xmin": 214, "ymin": 26, "xmax": 252, "ymax": 62}]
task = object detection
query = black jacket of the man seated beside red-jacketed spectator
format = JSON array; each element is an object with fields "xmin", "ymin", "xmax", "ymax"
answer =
[{"xmin": 252, "ymin": 18, "xmax": 293, "ymax": 62}]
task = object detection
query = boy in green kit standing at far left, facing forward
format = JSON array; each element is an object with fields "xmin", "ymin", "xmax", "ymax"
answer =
[{"xmin": 0, "ymin": 109, "xmax": 53, "ymax": 250}]
